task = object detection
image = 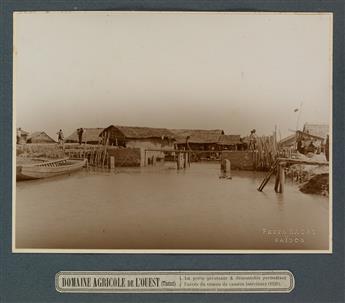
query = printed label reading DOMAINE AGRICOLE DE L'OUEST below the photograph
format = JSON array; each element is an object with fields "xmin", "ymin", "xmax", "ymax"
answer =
[{"xmin": 55, "ymin": 270, "xmax": 295, "ymax": 293}]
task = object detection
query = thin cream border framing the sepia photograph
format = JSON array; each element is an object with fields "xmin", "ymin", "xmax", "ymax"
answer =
[{"xmin": 12, "ymin": 11, "xmax": 333, "ymax": 254}]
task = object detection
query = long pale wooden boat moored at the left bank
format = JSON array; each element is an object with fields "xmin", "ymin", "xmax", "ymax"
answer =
[{"xmin": 16, "ymin": 158, "xmax": 87, "ymax": 181}]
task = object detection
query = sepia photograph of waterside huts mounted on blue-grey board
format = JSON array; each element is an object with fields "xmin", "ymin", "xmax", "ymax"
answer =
[{"xmin": 12, "ymin": 11, "xmax": 333, "ymax": 253}]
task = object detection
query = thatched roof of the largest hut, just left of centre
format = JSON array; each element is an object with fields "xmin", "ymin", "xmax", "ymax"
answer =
[{"xmin": 100, "ymin": 125, "xmax": 174, "ymax": 139}]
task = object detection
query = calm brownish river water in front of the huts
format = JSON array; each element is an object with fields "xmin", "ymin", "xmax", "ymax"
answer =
[{"xmin": 15, "ymin": 163, "xmax": 329, "ymax": 250}]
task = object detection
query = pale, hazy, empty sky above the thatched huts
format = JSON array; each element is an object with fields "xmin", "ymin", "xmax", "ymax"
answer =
[{"xmin": 14, "ymin": 12, "xmax": 332, "ymax": 138}]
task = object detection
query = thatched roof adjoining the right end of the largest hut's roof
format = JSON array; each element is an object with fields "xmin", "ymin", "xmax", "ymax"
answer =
[{"xmin": 170, "ymin": 129, "xmax": 224, "ymax": 144}]
